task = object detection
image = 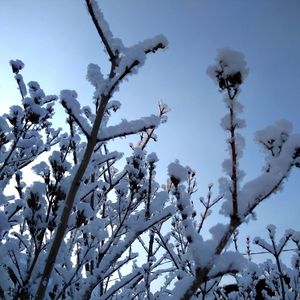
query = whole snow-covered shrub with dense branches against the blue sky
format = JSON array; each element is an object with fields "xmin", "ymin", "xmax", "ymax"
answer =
[{"xmin": 0, "ymin": 0, "xmax": 300, "ymax": 299}]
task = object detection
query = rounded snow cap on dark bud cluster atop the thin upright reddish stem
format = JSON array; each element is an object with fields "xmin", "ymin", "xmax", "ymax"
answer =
[{"xmin": 207, "ymin": 48, "xmax": 249, "ymax": 90}]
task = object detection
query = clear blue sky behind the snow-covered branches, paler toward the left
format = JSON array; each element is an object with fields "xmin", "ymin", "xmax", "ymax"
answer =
[{"xmin": 0, "ymin": 0, "xmax": 300, "ymax": 258}]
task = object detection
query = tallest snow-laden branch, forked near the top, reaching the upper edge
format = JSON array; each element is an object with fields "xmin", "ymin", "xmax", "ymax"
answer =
[{"xmin": 36, "ymin": 1, "xmax": 165, "ymax": 299}]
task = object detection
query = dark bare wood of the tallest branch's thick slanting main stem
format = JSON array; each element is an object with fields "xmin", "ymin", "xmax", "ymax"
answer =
[{"xmin": 35, "ymin": 0, "xmax": 165, "ymax": 300}]
